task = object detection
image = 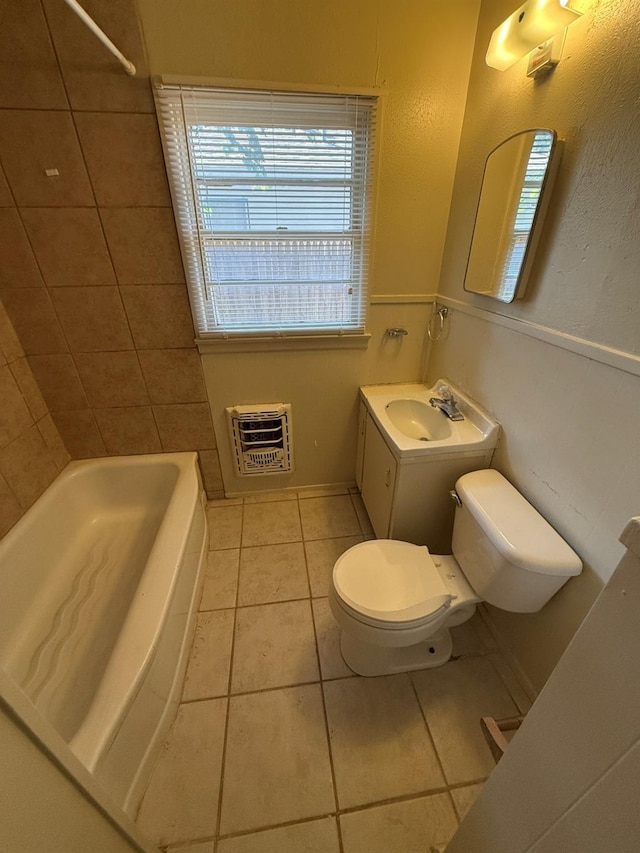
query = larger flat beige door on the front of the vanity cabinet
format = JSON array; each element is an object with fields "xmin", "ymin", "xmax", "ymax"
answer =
[{"xmin": 362, "ymin": 414, "xmax": 396, "ymax": 539}]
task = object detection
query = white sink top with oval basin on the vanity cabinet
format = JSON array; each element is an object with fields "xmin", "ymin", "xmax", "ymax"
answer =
[{"xmin": 360, "ymin": 379, "xmax": 500, "ymax": 458}]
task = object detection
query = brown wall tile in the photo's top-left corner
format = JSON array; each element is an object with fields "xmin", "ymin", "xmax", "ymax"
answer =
[{"xmin": 0, "ymin": 0, "xmax": 68, "ymax": 110}]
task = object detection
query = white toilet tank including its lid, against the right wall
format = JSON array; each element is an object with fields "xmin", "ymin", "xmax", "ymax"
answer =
[{"xmin": 453, "ymin": 470, "xmax": 582, "ymax": 613}]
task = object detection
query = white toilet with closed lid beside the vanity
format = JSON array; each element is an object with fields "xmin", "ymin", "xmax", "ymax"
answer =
[{"xmin": 329, "ymin": 470, "xmax": 582, "ymax": 676}]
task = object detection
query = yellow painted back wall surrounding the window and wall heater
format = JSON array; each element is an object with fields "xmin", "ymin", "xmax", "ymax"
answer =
[{"xmin": 138, "ymin": 0, "xmax": 479, "ymax": 492}]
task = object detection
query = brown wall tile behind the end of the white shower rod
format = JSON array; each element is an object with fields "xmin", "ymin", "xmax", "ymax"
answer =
[{"xmin": 44, "ymin": 0, "xmax": 153, "ymax": 113}]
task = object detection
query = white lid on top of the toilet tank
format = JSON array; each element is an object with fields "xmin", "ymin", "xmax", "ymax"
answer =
[{"xmin": 456, "ymin": 469, "xmax": 582, "ymax": 577}]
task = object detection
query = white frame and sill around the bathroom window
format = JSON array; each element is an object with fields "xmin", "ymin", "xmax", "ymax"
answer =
[{"xmin": 154, "ymin": 78, "xmax": 379, "ymax": 352}]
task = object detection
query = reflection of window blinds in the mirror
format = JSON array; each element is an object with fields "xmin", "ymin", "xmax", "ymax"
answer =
[{"xmin": 496, "ymin": 133, "xmax": 553, "ymax": 301}]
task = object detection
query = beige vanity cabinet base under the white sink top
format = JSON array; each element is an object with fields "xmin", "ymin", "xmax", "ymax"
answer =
[{"xmin": 356, "ymin": 402, "xmax": 493, "ymax": 554}]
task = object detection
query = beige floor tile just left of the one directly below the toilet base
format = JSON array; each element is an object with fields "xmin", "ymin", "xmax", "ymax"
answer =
[{"xmin": 220, "ymin": 684, "xmax": 335, "ymax": 834}]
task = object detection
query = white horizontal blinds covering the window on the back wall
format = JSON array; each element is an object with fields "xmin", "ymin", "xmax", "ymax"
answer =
[{"xmin": 156, "ymin": 84, "xmax": 376, "ymax": 339}]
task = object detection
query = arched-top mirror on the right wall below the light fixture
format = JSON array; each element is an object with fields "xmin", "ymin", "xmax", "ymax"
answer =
[{"xmin": 464, "ymin": 129, "xmax": 559, "ymax": 302}]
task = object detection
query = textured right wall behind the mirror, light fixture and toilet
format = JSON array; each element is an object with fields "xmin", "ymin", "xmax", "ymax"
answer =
[{"xmin": 428, "ymin": 0, "xmax": 640, "ymax": 688}]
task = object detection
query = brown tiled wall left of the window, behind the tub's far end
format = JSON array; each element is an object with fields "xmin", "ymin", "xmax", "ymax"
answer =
[{"xmin": 0, "ymin": 0, "xmax": 222, "ymax": 497}]
